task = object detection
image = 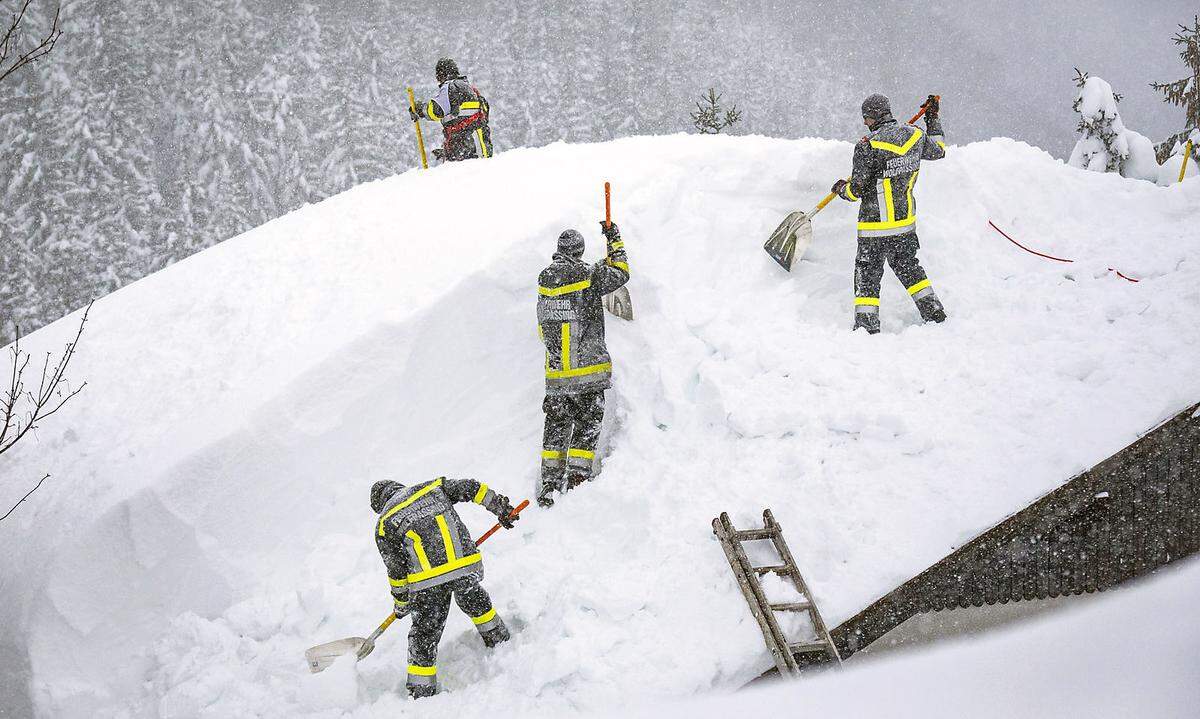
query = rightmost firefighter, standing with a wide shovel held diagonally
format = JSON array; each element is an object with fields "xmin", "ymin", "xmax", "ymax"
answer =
[{"xmin": 833, "ymin": 95, "xmax": 946, "ymax": 335}]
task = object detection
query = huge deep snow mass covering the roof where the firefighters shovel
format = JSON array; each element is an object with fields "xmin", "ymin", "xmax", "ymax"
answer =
[{"xmin": 0, "ymin": 136, "xmax": 1200, "ymax": 718}]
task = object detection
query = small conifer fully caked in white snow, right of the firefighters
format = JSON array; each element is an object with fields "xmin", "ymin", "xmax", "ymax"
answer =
[{"xmin": 1067, "ymin": 70, "xmax": 1158, "ymax": 181}]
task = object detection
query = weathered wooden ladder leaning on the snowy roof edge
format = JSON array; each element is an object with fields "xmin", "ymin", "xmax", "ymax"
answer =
[{"xmin": 713, "ymin": 509, "xmax": 841, "ymax": 677}]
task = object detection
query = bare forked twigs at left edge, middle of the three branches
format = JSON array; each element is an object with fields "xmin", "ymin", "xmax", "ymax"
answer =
[{"xmin": 0, "ymin": 305, "xmax": 91, "ymax": 455}]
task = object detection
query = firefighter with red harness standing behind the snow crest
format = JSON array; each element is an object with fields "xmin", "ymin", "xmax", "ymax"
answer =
[{"xmin": 408, "ymin": 58, "xmax": 492, "ymax": 162}]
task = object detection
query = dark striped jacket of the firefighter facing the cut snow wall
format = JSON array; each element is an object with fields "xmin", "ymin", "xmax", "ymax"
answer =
[{"xmin": 538, "ymin": 232, "xmax": 629, "ymax": 395}]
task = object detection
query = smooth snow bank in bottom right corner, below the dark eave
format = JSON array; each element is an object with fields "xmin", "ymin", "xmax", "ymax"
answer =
[{"xmin": 614, "ymin": 559, "xmax": 1200, "ymax": 719}]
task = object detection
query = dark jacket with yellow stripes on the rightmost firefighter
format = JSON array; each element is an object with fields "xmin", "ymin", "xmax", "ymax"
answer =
[{"xmin": 839, "ymin": 118, "xmax": 946, "ymax": 238}]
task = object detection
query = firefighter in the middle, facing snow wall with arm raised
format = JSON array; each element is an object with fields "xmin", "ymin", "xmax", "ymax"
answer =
[{"xmin": 538, "ymin": 222, "xmax": 629, "ymax": 507}]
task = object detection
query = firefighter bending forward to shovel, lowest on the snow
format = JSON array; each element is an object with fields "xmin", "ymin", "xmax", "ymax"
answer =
[{"xmin": 371, "ymin": 478, "xmax": 520, "ymax": 699}]
